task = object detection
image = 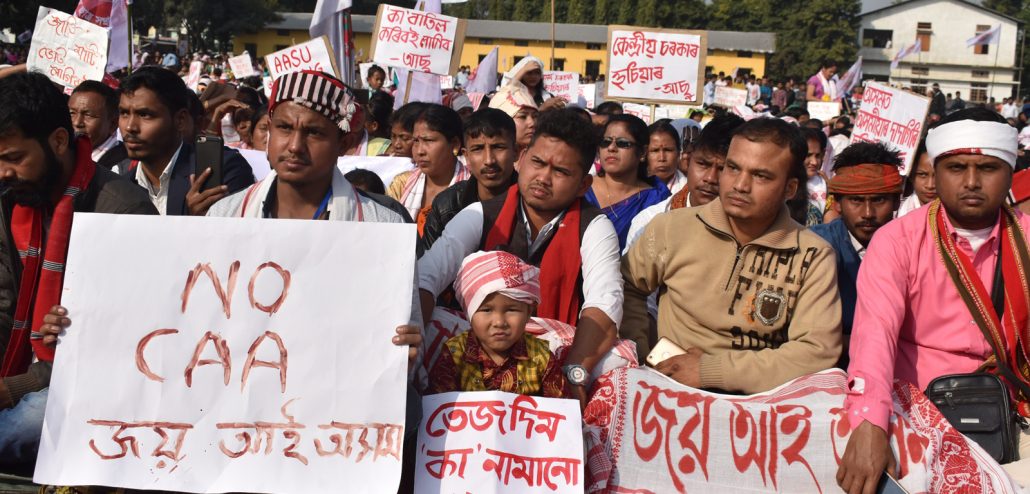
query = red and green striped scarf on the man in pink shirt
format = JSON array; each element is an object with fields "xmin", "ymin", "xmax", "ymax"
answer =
[{"xmin": 929, "ymin": 199, "xmax": 1030, "ymax": 417}]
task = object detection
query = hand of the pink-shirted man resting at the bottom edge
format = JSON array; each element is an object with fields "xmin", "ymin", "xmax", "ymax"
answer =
[{"xmin": 837, "ymin": 421, "xmax": 898, "ymax": 494}]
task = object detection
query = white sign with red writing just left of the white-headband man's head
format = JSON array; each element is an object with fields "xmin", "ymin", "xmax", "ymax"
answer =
[{"xmin": 851, "ymin": 81, "xmax": 930, "ymax": 176}]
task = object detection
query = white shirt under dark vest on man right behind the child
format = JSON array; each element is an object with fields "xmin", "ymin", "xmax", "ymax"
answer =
[{"xmin": 418, "ymin": 203, "xmax": 623, "ymax": 326}]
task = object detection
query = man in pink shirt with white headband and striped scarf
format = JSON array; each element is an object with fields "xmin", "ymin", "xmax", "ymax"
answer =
[{"xmin": 836, "ymin": 107, "xmax": 1030, "ymax": 494}]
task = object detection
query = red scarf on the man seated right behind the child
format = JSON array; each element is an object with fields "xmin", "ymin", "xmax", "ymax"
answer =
[{"xmin": 483, "ymin": 184, "xmax": 583, "ymax": 326}]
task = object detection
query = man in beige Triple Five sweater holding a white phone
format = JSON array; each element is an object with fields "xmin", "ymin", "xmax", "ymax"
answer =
[{"xmin": 621, "ymin": 118, "xmax": 840, "ymax": 386}]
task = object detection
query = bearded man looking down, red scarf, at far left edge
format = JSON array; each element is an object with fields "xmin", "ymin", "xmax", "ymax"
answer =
[{"xmin": 0, "ymin": 73, "xmax": 157, "ymax": 464}]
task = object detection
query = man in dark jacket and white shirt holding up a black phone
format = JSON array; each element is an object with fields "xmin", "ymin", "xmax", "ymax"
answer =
[{"xmin": 118, "ymin": 67, "xmax": 254, "ymax": 215}]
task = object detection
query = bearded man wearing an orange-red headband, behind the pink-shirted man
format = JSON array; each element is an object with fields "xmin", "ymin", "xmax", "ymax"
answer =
[{"xmin": 812, "ymin": 142, "xmax": 904, "ymax": 369}]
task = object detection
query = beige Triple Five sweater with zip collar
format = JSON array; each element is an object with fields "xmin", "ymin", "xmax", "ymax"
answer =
[{"xmin": 620, "ymin": 200, "xmax": 842, "ymax": 394}]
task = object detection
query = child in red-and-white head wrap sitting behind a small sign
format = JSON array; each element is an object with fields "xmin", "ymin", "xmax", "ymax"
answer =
[{"xmin": 430, "ymin": 251, "xmax": 565, "ymax": 398}]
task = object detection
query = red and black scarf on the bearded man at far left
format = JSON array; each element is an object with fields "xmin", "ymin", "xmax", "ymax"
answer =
[{"xmin": 0, "ymin": 139, "xmax": 97, "ymax": 377}]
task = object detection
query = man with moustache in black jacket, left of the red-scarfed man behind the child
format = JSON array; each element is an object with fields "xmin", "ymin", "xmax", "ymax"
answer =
[{"xmin": 421, "ymin": 108, "xmax": 518, "ymax": 250}]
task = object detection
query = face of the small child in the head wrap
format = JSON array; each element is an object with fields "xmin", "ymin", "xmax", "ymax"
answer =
[{"xmin": 472, "ymin": 293, "xmax": 530, "ymax": 357}]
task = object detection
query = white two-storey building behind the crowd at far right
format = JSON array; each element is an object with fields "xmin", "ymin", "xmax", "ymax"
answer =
[{"xmin": 859, "ymin": 0, "xmax": 1023, "ymax": 103}]
